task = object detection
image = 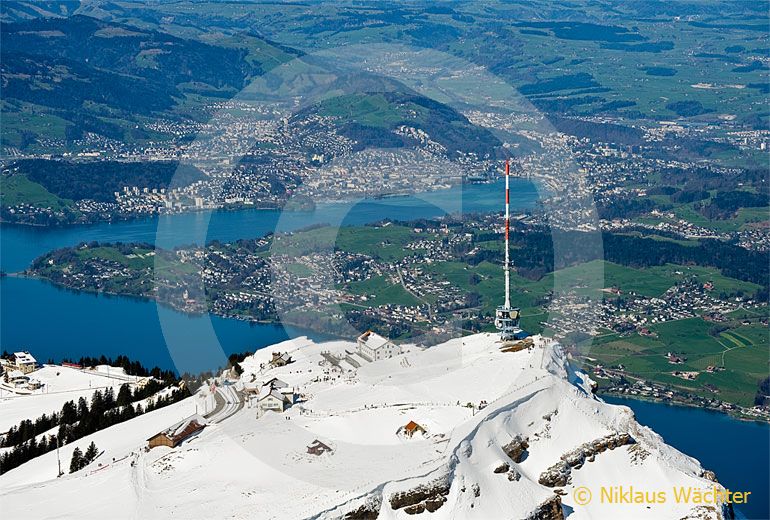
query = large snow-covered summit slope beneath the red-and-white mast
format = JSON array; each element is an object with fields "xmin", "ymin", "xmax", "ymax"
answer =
[{"xmin": 0, "ymin": 334, "xmax": 732, "ymax": 520}]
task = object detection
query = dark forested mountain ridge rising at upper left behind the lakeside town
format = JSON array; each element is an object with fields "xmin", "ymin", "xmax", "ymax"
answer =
[{"xmin": 0, "ymin": 12, "xmax": 288, "ymax": 149}]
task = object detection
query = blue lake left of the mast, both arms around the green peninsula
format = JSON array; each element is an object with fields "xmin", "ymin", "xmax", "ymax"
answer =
[{"xmin": 0, "ymin": 179, "xmax": 538, "ymax": 372}]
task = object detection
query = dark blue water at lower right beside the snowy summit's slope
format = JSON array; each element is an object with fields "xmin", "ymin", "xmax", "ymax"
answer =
[{"xmin": 603, "ymin": 397, "xmax": 770, "ymax": 520}]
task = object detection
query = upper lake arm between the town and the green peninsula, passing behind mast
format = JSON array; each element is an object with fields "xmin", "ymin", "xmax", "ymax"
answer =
[{"xmin": 0, "ymin": 178, "xmax": 538, "ymax": 272}]
